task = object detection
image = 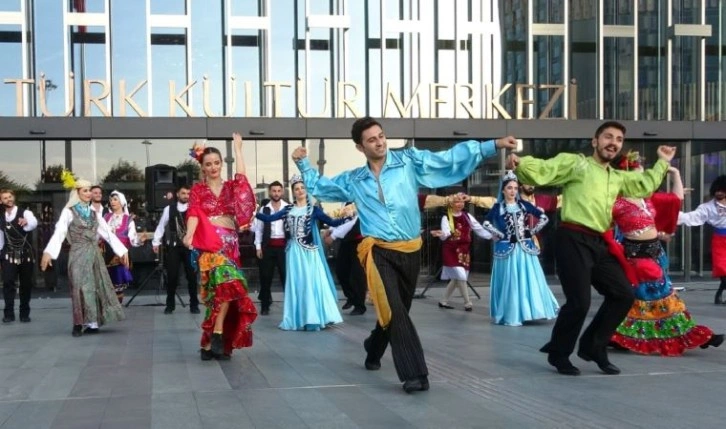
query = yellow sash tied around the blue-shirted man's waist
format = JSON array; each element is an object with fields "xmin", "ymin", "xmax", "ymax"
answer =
[{"xmin": 358, "ymin": 237, "xmax": 422, "ymax": 328}]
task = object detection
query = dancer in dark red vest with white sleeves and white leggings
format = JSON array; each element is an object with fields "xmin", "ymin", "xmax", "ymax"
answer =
[{"xmin": 431, "ymin": 197, "xmax": 492, "ymax": 311}]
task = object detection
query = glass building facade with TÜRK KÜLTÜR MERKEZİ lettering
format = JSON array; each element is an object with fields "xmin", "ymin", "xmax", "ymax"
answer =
[{"xmin": 0, "ymin": 0, "xmax": 726, "ymax": 276}]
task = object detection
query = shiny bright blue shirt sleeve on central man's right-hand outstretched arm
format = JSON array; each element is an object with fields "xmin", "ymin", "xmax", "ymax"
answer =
[{"xmin": 405, "ymin": 140, "xmax": 497, "ymax": 188}]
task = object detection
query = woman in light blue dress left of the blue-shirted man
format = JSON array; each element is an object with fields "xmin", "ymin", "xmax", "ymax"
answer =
[{"xmin": 256, "ymin": 175, "xmax": 347, "ymax": 331}]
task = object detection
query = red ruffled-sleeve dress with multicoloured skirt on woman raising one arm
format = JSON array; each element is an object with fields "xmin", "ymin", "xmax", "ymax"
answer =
[{"xmin": 187, "ymin": 174, "xmax": 257, "ymax": 356}]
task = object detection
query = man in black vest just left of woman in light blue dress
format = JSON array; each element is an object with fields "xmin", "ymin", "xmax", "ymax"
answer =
[{"xmin": 254, "ymin": 181, "xmax": 289, "ymax": 316}]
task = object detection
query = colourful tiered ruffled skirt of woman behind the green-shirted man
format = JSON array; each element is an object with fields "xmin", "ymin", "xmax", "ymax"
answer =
[{"xmin": 612, "ymin": 248, "xmax": 713, "ymax": 356}]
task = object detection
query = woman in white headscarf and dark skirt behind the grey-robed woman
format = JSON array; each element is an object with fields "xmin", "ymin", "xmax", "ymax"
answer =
[{"xmin": 103, "ymin": 191, "xmax": 144, "ymax": 303}]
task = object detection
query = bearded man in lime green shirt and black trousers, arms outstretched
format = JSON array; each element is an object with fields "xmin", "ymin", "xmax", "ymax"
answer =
[{"xmin": 507, "ymin": 121, "xmax": 676, "ymax": 375}]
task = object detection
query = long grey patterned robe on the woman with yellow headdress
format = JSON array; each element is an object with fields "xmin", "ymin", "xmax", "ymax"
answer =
[{"xmin": 66, "ymin": 206, "xmax": 125, "ymax": 325}]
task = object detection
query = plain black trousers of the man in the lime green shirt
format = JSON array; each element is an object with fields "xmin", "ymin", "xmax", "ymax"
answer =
[{"xmin": 543, "ymin": 227, "xmax": 635, "ymax": 357}]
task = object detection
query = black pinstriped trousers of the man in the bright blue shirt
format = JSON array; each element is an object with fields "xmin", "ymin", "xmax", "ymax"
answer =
[{"xmin": 368, "ymin": 247, "xmax": 429, "ymax": 381}]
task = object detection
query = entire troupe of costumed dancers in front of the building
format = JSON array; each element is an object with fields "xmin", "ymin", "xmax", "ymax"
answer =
[{"xmin": 0, "ymin": 117, "xmax": 726, "ymax": 393}]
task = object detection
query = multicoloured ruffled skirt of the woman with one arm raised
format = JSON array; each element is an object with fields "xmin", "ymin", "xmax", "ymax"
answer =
[{"xmin": 197, "ymin": 226, "xmax": 257, "ymax": 355}]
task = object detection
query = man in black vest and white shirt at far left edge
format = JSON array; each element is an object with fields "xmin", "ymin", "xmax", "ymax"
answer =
[{"xmin": 0, "ymin": 189, "xmax": 38, "ymax": 323}]
